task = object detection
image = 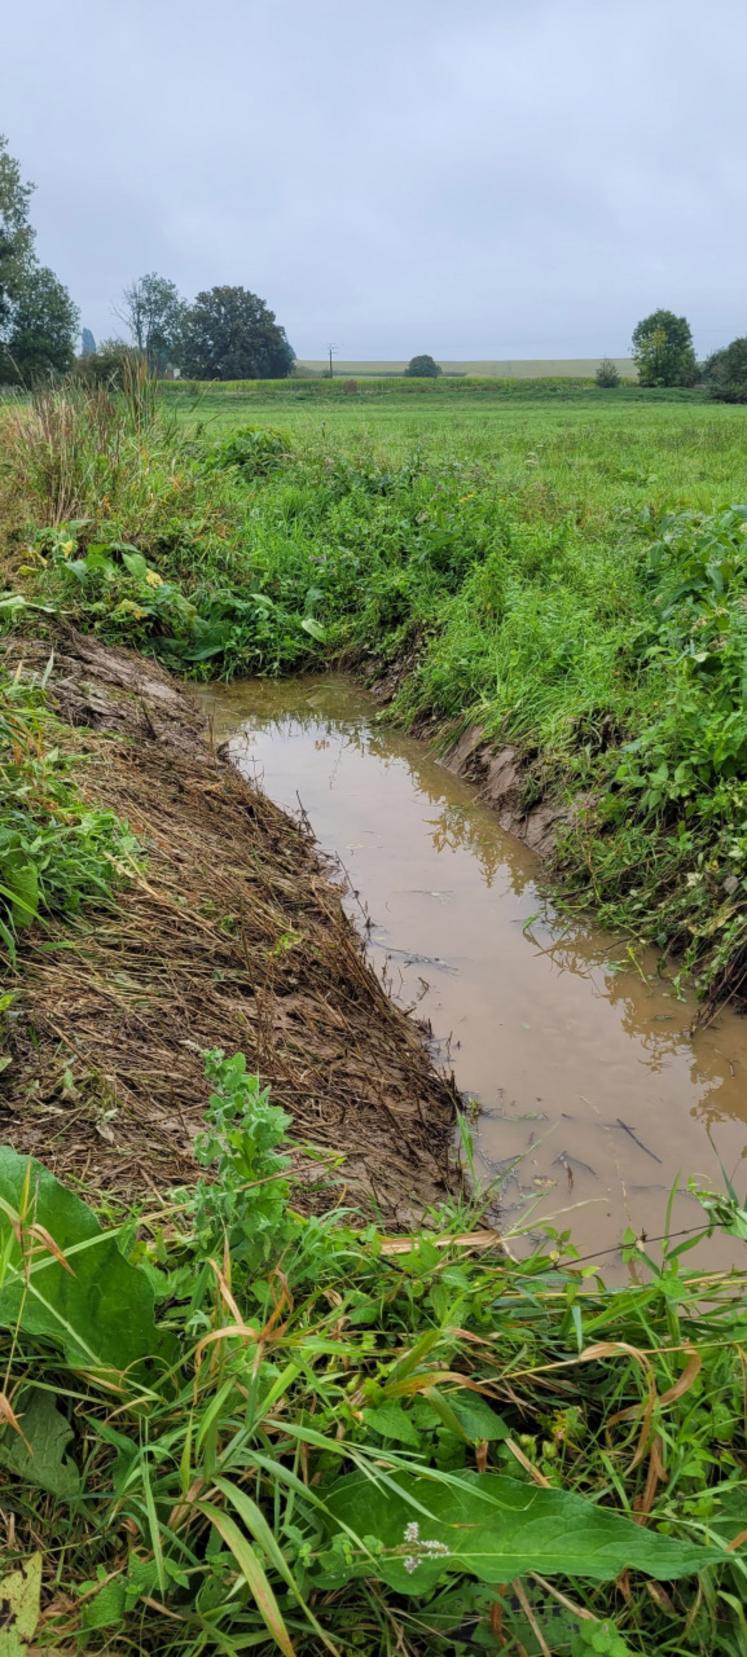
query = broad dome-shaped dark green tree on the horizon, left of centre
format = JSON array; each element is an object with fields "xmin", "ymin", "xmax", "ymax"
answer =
[{"xmin": 182, "ymin": 287, "xmax": 295, "ymax": 379}]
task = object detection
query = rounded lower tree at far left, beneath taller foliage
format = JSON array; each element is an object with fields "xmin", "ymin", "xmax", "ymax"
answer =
[{"xmin": 5, "ymin": 265, "xmax": 78, "ymax": 383}]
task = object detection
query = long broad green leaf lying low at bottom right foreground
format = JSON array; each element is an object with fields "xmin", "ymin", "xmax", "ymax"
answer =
[{"xmin": 326, "ymin": 1471, "xmax": 724, "ymax": 1594}]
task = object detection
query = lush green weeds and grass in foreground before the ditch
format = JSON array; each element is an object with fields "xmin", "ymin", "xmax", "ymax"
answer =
[{"xmin": 0, "ymin": 1052, "xmax": 747, "ymax": 1657}]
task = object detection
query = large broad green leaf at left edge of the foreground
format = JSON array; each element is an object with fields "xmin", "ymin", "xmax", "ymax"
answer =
[{"xmin": 0, "ymin": 1145, "xmax": 172, "ymax": 1372}]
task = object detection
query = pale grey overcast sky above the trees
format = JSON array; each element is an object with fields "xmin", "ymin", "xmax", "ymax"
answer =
[{"xmin": 0, "ymin": 0, "xmax": 747, "ymax": 360}]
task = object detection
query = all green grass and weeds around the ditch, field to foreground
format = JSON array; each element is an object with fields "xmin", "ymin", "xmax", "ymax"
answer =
[{"xmin": 0, "ymin": 381, "xmax": 747, "ymax": 1657}]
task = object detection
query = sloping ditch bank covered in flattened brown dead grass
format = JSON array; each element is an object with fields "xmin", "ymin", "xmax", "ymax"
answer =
[{"xmin": 0, "ymin": 631, "xmax": 455, "ymax": 1223}]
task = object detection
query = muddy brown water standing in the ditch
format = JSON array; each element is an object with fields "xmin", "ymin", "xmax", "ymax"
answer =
[{"xmin": 202, "ymin": 676, "xmax": 747, "ymax": 1276}]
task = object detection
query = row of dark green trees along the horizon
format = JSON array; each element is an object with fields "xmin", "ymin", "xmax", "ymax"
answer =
[{"xmin": 0, "ymin": 134, "xmax": 747, "ymax": 403}]
